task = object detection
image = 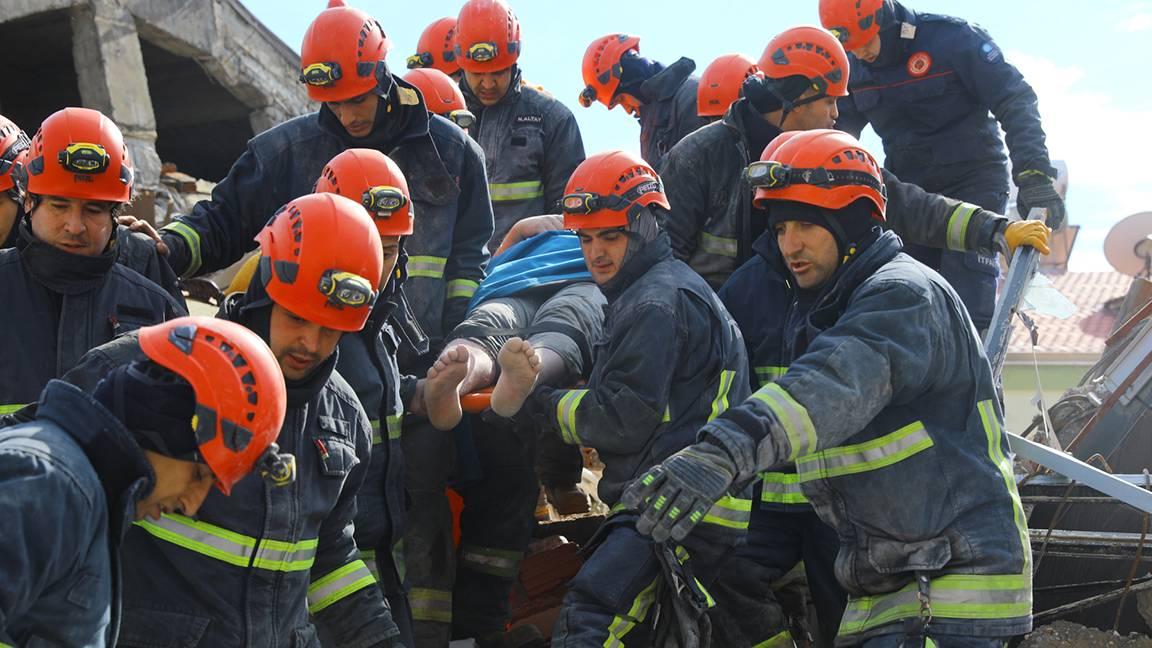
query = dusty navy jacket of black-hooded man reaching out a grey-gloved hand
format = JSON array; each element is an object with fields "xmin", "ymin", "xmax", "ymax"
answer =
[{"xmin": 700, "ymin": 233, "xmax": 1032, "ymax": 640}]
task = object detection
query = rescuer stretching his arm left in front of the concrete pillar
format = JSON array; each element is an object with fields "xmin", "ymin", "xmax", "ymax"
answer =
[{"xmin": 150, "ymin": 0, "xmax": 492, "ymax": 371}]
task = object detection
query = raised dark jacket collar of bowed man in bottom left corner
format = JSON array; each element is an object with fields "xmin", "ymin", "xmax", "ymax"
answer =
[{"xmin": 36, "ymin": 380, "xmax": 156, "ymax": 538}]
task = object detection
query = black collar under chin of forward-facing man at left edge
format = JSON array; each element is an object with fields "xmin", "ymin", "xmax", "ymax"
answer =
[{"xmin": 17, "ymin": 221, "xmax": 118, "ymax": 295}]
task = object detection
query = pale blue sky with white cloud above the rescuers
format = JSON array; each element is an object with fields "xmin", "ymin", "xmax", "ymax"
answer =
[{"xmin": 242, "ymin": 0, "xmax": 1152, "ymax": 271}]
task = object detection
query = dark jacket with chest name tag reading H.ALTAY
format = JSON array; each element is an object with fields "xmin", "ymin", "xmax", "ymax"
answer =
[{"xmin": 460, "ymin": 70, "xmax": 584, "ymax": 250}]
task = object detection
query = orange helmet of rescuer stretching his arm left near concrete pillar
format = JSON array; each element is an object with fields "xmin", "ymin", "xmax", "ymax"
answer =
[{"xmin": 300, "ymin": 0, "xmax": 392, "ymax": 101}]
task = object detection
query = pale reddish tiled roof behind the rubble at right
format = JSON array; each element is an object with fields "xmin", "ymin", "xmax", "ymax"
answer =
[{"xmin": 1008, "ymin": 271, "xmax": 1132, "ymax": 354}]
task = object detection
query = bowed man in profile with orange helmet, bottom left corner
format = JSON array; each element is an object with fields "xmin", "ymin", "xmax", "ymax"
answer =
[{"xmin": 0, "ymin": 317, "xmax": 290, "ymax": 647}]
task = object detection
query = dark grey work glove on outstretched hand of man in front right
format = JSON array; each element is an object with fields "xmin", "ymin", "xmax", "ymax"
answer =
[{"xmin": 620, "ymin": 442, "xmax": 736, "ymax": 542}]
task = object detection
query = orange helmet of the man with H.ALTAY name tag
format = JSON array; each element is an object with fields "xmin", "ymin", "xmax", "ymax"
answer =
[{"xmin": 455, "ymin": 0, "xmax": 521, "ymax": 71}]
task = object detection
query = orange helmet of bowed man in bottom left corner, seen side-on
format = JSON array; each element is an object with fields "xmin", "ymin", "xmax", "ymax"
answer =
[{"xmin": 139, "ymin": 317, "xmax": 295, "ymax": 495}]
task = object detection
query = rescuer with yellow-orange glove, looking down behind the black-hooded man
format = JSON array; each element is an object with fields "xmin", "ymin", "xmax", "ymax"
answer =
[{"xmin": 661, "ymin": 27, "xmax": 1046, "ymax": 288}]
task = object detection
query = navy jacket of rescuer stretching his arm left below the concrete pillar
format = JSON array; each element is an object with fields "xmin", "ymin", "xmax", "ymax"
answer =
[{"xmin": 162, "ymin": 78, "xmax": 492, "ymax": 340}]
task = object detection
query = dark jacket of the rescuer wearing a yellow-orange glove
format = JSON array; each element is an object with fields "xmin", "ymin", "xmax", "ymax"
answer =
[{"xmin": 660, "ymin": 100, "xmax": 1008, "ymax": 288}]
